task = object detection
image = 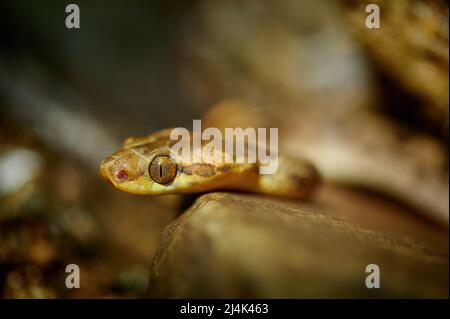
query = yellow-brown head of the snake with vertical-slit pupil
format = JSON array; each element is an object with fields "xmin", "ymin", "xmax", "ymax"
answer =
[{"xmin": 100, "ymin": 130, "xmax": 257, "ymax": 195}]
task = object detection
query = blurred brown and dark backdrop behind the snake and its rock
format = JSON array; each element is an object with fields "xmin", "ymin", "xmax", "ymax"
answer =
[{"xmin": 0, "ymin": 0, "xmax": 449, "ymax": 298}]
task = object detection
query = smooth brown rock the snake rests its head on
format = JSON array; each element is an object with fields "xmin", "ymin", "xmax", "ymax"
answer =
[{"xmin": 147, "ymin": 189, "xmax": 448, "ymax": 298}]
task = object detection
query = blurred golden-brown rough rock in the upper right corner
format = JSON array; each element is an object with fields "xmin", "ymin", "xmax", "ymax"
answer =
[{"xmin": 341, "ymin": 0, "xmax": 449, "ymax": 132}]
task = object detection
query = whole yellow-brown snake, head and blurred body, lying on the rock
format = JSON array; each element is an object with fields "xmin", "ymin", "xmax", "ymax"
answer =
[{"xmin": 100, "ymin": 129, "xmax": 321, "ymax": 199}]
